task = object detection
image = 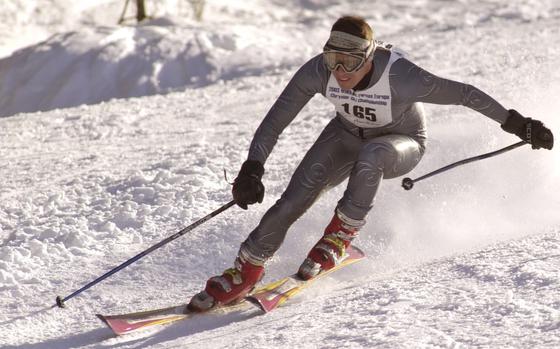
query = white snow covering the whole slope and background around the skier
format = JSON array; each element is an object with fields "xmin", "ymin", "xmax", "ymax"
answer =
[{"xmin": 0, "ymin": 0, "xmax": 560, "ymax": 348}]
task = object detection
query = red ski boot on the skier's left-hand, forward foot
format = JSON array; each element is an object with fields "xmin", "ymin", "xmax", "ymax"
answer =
[{"xmin": 188, "ymin": 256, "xmax": 264, "ymax": 311}]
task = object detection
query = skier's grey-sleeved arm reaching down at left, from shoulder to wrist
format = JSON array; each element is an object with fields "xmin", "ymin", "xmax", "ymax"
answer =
[{"xmin": 248, "ymin": 55, "xmax": 328, "ymax": 165}]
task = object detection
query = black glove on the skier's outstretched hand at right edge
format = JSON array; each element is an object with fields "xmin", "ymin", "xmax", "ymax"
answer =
[{"xmin": 502, "ymin": 109, "xmax": 554, "ymax": 149}]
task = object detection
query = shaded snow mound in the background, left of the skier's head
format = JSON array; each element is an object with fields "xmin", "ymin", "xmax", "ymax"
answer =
[{"xmin": 0, "ymin": 18, "xmax": 316, "ymax": 116}]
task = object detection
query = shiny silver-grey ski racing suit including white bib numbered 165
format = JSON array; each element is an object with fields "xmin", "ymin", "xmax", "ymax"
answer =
[{"xmin": 240, "ymin": 46, "xmax": 509, "ymax": 264}]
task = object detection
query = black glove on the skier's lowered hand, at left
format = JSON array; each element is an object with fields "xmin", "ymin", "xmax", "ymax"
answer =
[{"xmin": 231, "ymin": 160, "xmax": 264, "ymax": 210}]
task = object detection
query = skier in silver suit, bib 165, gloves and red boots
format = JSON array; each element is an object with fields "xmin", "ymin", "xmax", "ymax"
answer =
[{"xmin": 189, "ymin": 16, "xmax": 553, "ymax": 311}]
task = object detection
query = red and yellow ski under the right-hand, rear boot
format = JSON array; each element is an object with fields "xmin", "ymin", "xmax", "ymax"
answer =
[{"xmin": 245, "ymin": 246, "xmax": 365, "ymax": 313}]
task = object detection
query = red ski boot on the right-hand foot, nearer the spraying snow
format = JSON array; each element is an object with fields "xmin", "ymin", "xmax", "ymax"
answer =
[{"xmin": 298, "ymin": 210, "xmax": 365, "ymax": 280}]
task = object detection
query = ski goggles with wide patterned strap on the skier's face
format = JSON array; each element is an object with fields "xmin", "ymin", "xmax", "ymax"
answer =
[{"xmin": 323, "ymin": 31, "xmax": 376, "ymax": 73}]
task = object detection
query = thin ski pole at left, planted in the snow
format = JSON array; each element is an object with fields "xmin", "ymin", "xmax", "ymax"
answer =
[{"xmin": 58, "ymin": 200, "xmax": 235, "ymax": 308}]
